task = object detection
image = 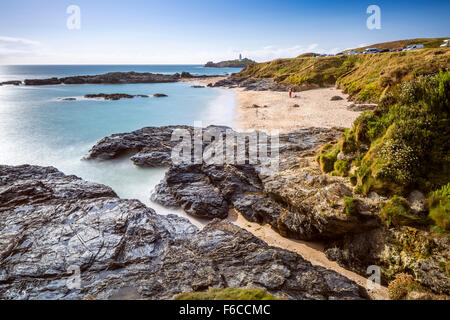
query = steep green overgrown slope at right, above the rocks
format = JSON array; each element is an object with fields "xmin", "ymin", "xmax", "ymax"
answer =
[{"xmin": 317, "ymin": 71, "xmax": 450, "ymax": 232}]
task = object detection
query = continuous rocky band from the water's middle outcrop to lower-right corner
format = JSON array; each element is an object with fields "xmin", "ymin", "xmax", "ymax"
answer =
[{"xmin": 87, "ymin": 126, "xmax": 450, "ymax": 295}]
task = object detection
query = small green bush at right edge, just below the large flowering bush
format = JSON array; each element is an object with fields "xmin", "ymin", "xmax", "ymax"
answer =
[{"xmin": 428, "ymin": 183, "xmax": 450, "ymax": 231}]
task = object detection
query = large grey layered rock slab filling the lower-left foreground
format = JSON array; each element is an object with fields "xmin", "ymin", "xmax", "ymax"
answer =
[{"xmin": 0, "ymin": 166, "xmax": 366, "ymax": 299}]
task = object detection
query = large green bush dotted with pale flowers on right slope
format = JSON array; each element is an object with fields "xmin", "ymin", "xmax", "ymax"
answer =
[{"xmin": 352, "ymin": 71, "xmax": 450, "ymax": 194}]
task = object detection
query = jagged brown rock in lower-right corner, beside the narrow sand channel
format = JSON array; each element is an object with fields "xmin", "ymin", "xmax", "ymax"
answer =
[{"xmin": 325, "ymin": 227, "xmax": 450, "ymax": 295}]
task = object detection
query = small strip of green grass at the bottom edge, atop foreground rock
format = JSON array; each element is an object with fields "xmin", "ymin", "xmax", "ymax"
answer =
[{"xmin": 175, "ymin": 288, "xmax": 279, "ymax": 300}]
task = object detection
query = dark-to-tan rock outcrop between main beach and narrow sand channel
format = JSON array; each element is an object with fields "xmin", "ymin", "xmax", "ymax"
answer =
[{"xmin": 87, "ymin": 127, "xmax": 375, "ymax": 240}]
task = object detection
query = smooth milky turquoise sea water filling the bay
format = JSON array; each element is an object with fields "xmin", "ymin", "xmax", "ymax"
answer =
[{"xmin": 0, "ymin": 66, "xmax": 239, "ymax": 221}]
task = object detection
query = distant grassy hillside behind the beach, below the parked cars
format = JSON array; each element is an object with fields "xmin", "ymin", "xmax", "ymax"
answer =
[{"xmin": 239, "ymin": 48, "xmax": 450, "ymax": 102}]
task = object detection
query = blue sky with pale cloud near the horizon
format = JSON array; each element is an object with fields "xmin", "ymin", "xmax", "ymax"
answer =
[{"xmin": 0, "ymin": 0, "xmax": 450, "ymax": 64}]
